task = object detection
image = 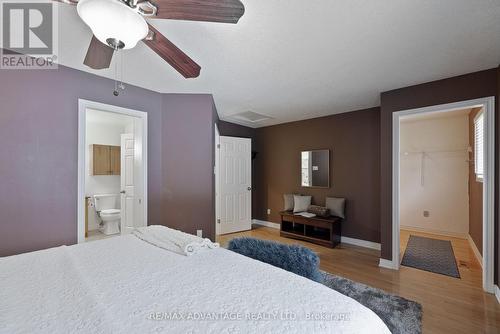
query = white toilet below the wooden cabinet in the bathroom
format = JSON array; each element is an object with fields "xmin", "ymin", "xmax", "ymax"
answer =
[{"xmin": 94, "ymin": 194, "xmax": 120, "ymax": 235}]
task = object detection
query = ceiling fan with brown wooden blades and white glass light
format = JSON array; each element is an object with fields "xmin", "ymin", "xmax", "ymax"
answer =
[{"xmin": 53, "ymin": 0, "xmax": 245, "ymax": 78}]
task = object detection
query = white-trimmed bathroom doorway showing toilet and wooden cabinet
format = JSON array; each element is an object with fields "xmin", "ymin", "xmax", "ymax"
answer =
[{"xmin": 77, "ymin": 99, "xmax": 147, "ymax": 243}]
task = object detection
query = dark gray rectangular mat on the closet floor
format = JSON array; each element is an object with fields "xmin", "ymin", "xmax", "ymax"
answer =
[{"xmin": 401, "ymin": 235, "xmax": 460, "ymax": 278}]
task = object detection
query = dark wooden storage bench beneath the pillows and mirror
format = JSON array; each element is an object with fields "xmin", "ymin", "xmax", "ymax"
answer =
[{"xmin": 280, "ymin": 211, "xmax": 342, "ymax": 248}]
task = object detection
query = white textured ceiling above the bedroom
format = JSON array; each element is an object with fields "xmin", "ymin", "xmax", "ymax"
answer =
[{"xmin": 54, "ymin": 0, "xmax": 500, "ymax": 126}]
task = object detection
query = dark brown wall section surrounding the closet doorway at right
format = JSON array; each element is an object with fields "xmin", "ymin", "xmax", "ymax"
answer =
[{"xmin": 380, "ymin": 68, "xmax": 500, "ymax": 281}]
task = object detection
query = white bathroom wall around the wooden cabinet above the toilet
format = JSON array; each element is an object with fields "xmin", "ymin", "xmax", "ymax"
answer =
[{"xmin": 85, "ymin": 110, "xmax": 133, "ymax": 231}]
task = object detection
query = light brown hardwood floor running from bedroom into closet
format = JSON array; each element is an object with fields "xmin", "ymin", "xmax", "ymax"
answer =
[{"xmin": 218, "ymin": 226, "xmax": 500, "ymax": 333}]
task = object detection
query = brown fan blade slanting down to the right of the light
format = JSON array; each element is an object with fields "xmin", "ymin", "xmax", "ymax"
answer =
[{"xmin": 143, "ymin": 25, "xmax": 201, "ymax": 79}]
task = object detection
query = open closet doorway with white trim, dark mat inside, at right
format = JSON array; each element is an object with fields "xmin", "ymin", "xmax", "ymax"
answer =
[{"xmin": 393, "ymin": 98, "xmax": 494, "ymax": 292}]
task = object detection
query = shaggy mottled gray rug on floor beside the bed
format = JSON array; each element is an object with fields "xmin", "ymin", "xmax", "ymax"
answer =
[{"xmin": 321, "ymin": 271, "xmax": 422, "ymax": 334}]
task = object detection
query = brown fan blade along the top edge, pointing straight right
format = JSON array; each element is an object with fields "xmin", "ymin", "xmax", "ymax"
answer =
[{"xmin": 150, "ymin": 0, "xmax": 245, "ymax": 23}]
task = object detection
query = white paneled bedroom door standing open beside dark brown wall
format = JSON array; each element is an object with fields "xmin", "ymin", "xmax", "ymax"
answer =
[{"xmin": 219, "ymin": 136, "xmax": 252, "ymax": 234}]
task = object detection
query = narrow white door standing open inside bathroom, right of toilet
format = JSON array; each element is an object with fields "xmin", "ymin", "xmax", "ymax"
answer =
[{"xmin": 120, "ymin": 133, "xmax": 136, "ymax": 234}]
